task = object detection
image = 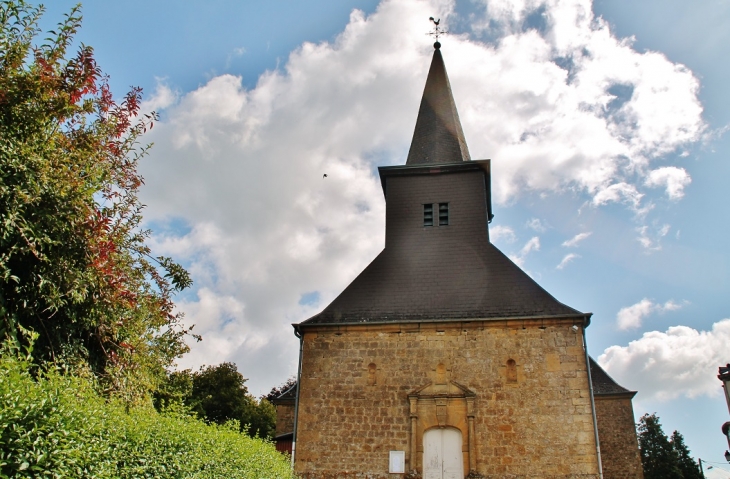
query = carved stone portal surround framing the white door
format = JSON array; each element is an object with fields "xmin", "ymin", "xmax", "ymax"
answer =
[{"xmin": 408, "ymin": 376, "xmax": 477, "ymax": 473}]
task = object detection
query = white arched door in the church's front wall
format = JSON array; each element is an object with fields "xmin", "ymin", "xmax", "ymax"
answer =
[{"xmin": 423, "ymin": 428, "xmax": 464, "ymax": 479}]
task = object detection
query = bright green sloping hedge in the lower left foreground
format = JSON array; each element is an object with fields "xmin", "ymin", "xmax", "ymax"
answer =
[{"xmin": 0, "ymin": 348, "xmax": 292, "ymax": 479}]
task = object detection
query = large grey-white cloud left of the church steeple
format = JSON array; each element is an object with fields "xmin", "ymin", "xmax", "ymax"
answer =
[{"xmin": 142, "ymin": 2, "xmax": 438, "ymax": 393}]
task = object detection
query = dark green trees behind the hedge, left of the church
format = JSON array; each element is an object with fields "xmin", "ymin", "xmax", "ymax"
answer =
[{"xmin": 183, "ymin": 363, "xmax": 276, "ymax": 438}]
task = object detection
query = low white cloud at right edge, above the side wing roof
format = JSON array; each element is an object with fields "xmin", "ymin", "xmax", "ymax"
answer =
[{"xmin": 598, "ymin": 319, "xmax": 730, "ymax": 401}]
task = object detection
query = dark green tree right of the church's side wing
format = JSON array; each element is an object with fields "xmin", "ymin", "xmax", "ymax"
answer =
[{"xmin": 637, "ymin": 414, "xmax": 702, "ymax": 479}]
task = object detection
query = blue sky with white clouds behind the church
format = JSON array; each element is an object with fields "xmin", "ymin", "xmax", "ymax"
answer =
[{"xmin": 38, "ymin": 0, "xmax": 730, "ymax": 468}]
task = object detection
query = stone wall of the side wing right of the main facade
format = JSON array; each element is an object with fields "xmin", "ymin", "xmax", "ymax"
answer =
[{"xmin": 596, "ymin": 395, "xmax": 644, "ymax": 479}]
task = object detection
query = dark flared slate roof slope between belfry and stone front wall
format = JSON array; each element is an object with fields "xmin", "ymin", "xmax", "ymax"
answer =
[{"xmin": 303, "ymin": 242, "xmax": 586, "ymax": 324}]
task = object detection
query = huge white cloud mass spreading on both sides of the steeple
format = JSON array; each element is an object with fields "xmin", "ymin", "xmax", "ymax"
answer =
[{"xmin": 136, "ymin": 0, "xmax": 704, "ymax": 391}]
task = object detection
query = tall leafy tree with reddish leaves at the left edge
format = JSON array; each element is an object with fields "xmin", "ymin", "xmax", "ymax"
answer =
[{"xmin": 0, "ymin": 0, "xmax": 191, "ymax": 399}]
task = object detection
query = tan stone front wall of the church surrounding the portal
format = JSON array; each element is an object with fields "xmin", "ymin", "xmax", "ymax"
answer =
[{"xmin": 295, "ymin": 320, "xmax": 598, "ymax": 479}]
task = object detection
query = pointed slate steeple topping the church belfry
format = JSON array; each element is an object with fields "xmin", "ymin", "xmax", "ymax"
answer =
[{"xmin": 406, "ymin": 42, "xmax": 471, "ymax": 165}]
